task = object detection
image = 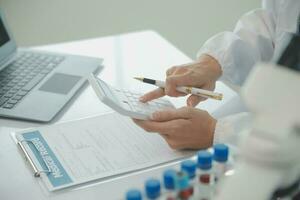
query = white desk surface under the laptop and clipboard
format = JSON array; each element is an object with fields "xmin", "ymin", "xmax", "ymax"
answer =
[{"xmin": 0, "ymin": 31, "xmax": 239, "ymax": 200}]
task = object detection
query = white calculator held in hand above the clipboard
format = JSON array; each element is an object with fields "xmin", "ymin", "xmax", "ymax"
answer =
[{"xmin": 88, "ymin": 74, "xmax": 174, "ymax": 120}]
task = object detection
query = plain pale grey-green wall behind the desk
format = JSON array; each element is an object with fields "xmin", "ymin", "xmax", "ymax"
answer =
[{"xmin": 0, "ymin": 0, "xmax": 260, "ymax": 57}]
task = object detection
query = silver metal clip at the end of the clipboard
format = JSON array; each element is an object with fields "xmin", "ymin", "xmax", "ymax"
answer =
[{"xmin": 17, "ymin": 140, "xmax": 52, "ymax": 177}]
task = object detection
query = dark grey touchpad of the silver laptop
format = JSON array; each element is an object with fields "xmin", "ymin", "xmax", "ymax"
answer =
[{"xmin": 39, "ymin": 73, "xmax": 81, "ymax": 94}]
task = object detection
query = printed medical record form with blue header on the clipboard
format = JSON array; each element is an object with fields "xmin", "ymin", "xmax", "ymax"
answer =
[{"xmin": 16, "ymin": 113, "xmax": 193, "ymax": 191}]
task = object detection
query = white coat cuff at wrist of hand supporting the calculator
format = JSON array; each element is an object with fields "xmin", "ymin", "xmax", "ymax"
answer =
[{"xmin": 213, "ymin": 112, "xmax": 252, "ymax": 147}]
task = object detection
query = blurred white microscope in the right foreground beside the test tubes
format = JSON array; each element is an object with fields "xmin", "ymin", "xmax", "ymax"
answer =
[{"xmin": 217, "ymin": 35, "xmax": 300, "ymax": 200}]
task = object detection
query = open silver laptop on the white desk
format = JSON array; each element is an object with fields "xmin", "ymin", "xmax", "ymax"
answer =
[{"xmin": 0, "ymin": 11, "xmax": 102, "ymax": 122}]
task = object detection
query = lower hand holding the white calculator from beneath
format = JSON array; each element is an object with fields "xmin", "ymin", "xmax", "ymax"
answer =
[{"xmin": 133, "ymin": 107, "xmax": 217, "ymax": 149}]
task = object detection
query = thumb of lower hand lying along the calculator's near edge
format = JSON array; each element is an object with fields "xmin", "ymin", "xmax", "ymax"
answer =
[{"xmin": 151, "ymin": 107, "xmax": 193, "ymax": 122}]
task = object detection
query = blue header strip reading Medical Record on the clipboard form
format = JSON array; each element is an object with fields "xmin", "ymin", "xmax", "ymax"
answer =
[{"xmin": 22, "ymin": 131, "xmax": 72, "ymax": 187}]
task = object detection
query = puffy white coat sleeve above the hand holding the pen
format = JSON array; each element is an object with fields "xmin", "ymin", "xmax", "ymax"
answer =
[{"xmin": 197, "ymin": 5, "xmax": 275, "ymax": 85}]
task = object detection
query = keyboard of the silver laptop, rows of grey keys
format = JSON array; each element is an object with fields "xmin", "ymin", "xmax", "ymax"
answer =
[{"xmin": 0, "ymin": 52, "xmax": 64, "ymax": 109}]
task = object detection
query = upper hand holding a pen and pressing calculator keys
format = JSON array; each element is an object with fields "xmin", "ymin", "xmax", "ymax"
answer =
[{"xmin": 140, "ymin": 54, "xmax": 222, "ymax": 107}]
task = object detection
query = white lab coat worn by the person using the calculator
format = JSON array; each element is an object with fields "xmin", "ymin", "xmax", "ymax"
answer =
[{"xmin": 198, "ymin": 0, "xmax": 300, "ymax": 144}]
